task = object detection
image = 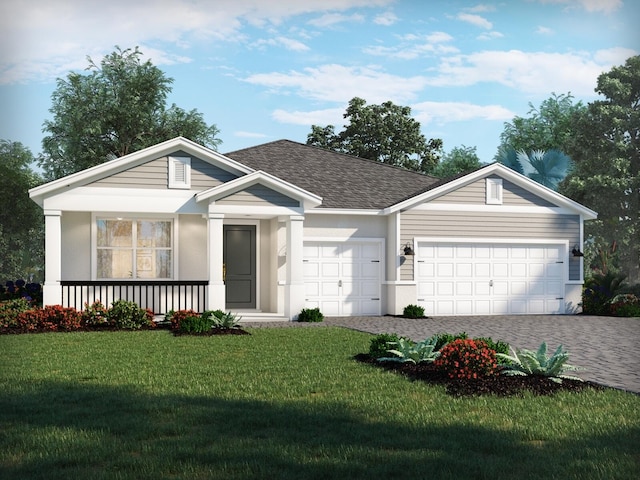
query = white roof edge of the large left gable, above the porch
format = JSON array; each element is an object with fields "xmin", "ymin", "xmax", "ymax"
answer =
[{"xmin": 29, "ymin": 137, "xmax": 254, "ymax": 206}]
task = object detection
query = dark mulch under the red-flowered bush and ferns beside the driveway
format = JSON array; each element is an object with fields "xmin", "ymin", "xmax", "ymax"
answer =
[{"xmin": 354, "ymin": 353, "xmax": 606, "ymax": 397}]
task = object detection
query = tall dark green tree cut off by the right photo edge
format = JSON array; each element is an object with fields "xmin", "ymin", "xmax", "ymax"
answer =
[{"xmin": 560, "ymin": 56, "xmax": 640, "ymax": 281}]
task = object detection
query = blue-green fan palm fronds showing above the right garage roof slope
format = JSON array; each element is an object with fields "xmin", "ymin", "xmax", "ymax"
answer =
[{"xmin": 498, "ymin": 148, "xmax": 573, "ymax": 190}]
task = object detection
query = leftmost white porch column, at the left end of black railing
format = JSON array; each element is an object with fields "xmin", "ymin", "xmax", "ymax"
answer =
[{"xmin": 42, "ymin": 210, "xmax": 62, "ymax": 306}]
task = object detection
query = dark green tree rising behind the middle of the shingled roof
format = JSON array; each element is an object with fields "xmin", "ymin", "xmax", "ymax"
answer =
[{"xmin": 307, "ymin": 97, "xmax": 442, "ymax": 173}]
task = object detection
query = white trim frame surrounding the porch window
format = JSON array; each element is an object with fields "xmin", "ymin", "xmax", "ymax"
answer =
[{"xmin": 91, "ymin": 212, "xmax": 180, "ymax": 283}]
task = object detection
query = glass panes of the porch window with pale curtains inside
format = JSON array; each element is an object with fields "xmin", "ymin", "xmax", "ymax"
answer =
[{"xmin": 96, "ymin": 218, "xmax": 173, "ymax": 279}]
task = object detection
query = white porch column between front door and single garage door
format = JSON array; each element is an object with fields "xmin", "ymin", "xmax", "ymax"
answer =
[{"xmin": 284, "ymin": 215, "xmax": 305, "ymax": 320}]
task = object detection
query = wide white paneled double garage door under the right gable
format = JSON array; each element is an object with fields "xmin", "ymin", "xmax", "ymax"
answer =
[{"xmin": 416, "ymin": 243, "xmax": 564, "ymax": 315}]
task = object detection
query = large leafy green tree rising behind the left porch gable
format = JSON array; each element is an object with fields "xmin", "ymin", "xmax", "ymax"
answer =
[{"xmin": 38, "ymin": 47, "xmax": 220, "ymax": 179}]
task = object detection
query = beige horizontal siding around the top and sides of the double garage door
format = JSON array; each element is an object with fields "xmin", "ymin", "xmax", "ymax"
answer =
[{"xmin": 400, "ymin": 210, "xmax": 580, "ymax": 281}]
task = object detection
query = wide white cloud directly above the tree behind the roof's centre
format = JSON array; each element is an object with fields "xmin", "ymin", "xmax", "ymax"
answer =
[{"xmin": 244, "ymin": 64, "xmax": 426, "ymax": 103}]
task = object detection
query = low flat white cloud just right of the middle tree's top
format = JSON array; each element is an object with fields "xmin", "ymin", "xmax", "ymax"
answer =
[{"xmin": 411, "ymin": 102, "xmax": 515, "ymax": 124}]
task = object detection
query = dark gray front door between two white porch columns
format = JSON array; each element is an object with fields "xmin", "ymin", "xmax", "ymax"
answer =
[{"xmin": 223, "ymin": 225, "xmax": 256, "ymax": 310}]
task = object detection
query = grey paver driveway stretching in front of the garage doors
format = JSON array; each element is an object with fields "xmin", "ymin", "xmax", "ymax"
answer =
[{"xmin": 243, "ymin": 315, "xmax": 640, "ymax": 394}]
